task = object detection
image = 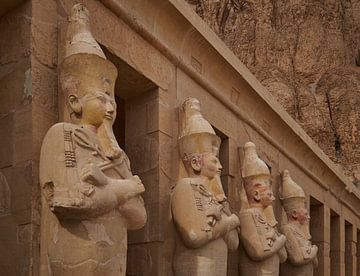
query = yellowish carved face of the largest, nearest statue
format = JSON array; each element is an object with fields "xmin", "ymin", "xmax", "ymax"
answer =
[{"xmin": 80, "ymin": 92, "xmax": 116, "ymax": 127}]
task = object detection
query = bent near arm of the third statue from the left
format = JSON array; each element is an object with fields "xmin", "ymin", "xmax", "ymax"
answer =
[{"xmin": 239, "ymin": 211, "xmax": 286, "ymax": 261}]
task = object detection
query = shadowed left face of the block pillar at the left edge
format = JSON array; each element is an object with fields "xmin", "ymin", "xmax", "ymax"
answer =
[{"xmin": 0, "ymin": 2, "xmax": 32, "ymax": 275}]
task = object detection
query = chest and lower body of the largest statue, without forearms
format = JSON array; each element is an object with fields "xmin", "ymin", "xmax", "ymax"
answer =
[{"xmin": 40, "ymin": 123, "xmax": 131, "ymax": 275}]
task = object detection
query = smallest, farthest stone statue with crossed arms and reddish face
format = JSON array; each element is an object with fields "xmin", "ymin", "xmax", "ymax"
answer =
[{"xmin": 280, "ymin": 170, "xmax": 318, "ymax": 276}]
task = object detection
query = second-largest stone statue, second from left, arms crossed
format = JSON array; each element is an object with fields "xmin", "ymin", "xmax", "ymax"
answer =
[{"xmin": 171, "ymin": 98, "xmax": 239, "ymax": 276}]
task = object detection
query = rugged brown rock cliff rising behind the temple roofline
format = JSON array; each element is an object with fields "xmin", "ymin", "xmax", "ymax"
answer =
[{"xmin": 185, "ymin": 0, "xmax": 360, "ymax": 185}]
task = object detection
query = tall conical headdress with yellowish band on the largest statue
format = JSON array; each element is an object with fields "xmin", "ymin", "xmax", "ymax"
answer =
[{"xmin": 60, "ymin": 4, "xmax": 117, "ymax": 100}]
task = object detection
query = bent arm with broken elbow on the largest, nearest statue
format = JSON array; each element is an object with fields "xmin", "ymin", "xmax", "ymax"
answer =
[{"xmin": 40, "ymin": 123, "xmax": 144, "ymax": 219}]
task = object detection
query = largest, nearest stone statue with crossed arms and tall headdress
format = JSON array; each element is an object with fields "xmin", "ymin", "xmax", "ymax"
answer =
[{"xmin": 40, "ymin": 4, "xmax": 146, "ymax": 276}]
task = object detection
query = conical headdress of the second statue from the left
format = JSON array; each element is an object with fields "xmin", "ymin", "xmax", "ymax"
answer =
[{"xmin": 179, "ymin": 98, "xmax": 221, "ymax": 158}]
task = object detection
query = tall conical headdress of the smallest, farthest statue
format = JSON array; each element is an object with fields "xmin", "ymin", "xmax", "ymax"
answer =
[{"xmin": 280, "ymin": 170, "xmax": 305, "ymax": 213}]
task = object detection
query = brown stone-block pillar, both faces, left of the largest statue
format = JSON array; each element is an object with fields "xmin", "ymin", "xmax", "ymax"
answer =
[{"xmin": 0, "ymin": 1, "xmax": 58, "ymax": 275}]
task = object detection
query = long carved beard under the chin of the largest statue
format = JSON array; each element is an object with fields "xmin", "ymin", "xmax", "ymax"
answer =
[{"xmin": 97, "ymin": 120, "xmax": 122, "ymax": 160}]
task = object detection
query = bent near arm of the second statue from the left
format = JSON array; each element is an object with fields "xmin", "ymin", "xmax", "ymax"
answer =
[{"xmin": 171, "ymin": 181, "xmax": 239, "ymax": 248}]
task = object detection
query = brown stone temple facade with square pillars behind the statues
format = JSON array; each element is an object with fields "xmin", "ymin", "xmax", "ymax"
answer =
[{"xmin": 0, "ymin": 0, "xmax": 360, "ymax": 276}]
